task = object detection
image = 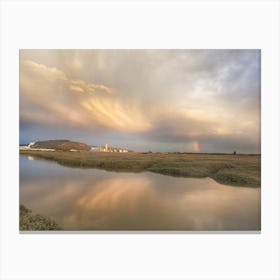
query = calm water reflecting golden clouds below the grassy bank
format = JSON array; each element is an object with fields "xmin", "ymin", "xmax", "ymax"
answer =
[{"xmin": 20, "ymin": 156, "xmax": 261, "ymax": 230}]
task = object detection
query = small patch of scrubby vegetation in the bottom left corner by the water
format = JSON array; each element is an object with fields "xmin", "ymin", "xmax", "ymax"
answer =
[{"xmin": 19, "ymin": 205, "xmax": 61, "ymax": 230}]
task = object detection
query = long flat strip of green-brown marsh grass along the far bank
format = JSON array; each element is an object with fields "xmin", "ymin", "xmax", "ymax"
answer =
[{"xmin": 20, "ymin": 151, "xmax": 261, "ymax": 187}]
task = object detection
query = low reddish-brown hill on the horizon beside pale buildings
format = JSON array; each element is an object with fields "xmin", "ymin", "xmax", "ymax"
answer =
[{"xmin": 32, "ymin": 140, "xmax": 91, "ymax": 151}]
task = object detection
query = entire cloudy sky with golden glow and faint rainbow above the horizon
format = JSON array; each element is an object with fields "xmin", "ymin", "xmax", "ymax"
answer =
[{"xmin": 19, "ymin": 49, "xmax": 261, "ymax": 153}]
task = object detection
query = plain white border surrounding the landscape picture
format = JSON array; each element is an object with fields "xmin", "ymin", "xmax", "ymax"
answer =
[{"xmin": 0, "ymin": 0, "xmax": 280, "ymax": 280}]
